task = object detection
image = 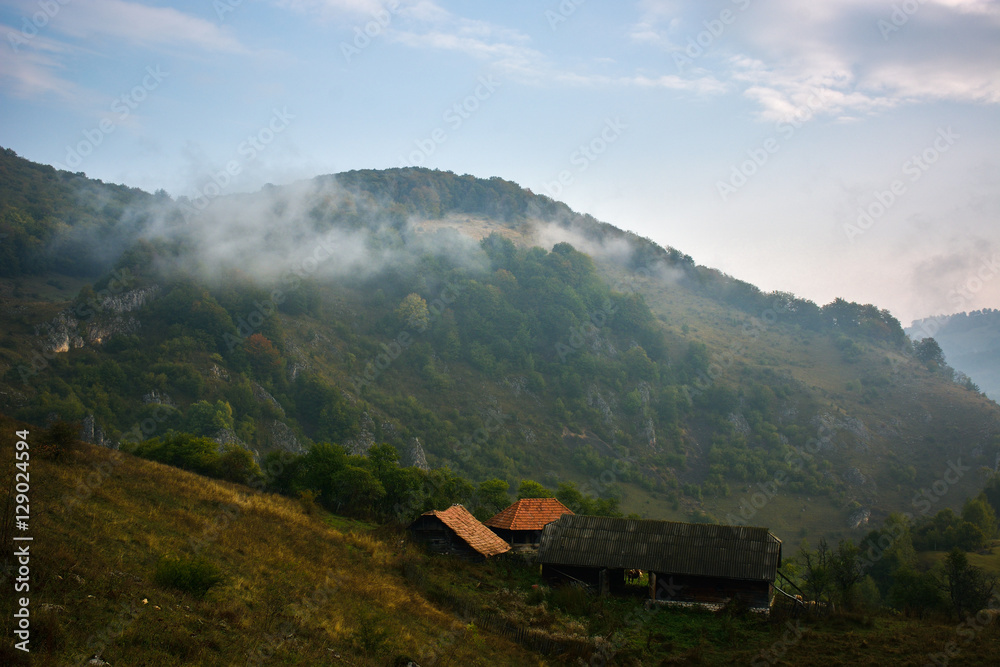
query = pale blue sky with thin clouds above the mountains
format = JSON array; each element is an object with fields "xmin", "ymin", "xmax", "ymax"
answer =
[{"xmin": 0, "ymin": 0, "xmax": 1000, "ymax": 326}]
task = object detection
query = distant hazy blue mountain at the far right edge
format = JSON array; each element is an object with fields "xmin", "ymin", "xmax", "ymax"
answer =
[{"xmin": 906, "ymin": 308, "xmax": 1000, "ymax": 400}]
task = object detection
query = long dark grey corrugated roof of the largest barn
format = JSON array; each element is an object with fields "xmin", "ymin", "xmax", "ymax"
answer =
[{"xmin": 537, "ymin": 514, "xmax": 781, "ymax": 581}]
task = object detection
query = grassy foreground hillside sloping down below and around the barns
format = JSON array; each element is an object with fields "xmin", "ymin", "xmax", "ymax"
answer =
[{"xmin": 0, "ymin": 419, "xmax": 1000, "ymax": 666}]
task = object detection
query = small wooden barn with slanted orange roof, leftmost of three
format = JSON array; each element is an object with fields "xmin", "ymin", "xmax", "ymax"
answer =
[{"xmin": 410, "ymin": 505, "xmax": 510, "ymax": 561}]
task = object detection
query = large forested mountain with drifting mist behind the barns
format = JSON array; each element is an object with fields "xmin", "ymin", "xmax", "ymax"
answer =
[{"xmin": 0, "ymin": 150, "xmax": 1000, "ymax": 539}]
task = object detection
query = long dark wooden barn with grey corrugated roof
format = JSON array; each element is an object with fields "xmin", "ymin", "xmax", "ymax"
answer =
[{"xmin": 536, "ymin": 515, "xmax": 781, "ymax": 609}]
